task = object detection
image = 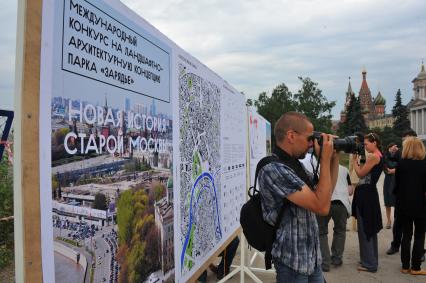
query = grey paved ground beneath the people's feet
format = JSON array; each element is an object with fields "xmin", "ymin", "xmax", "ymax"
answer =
[{"xmin": 208, "ymin": 175, "xmax": 426, "ymax": 283}]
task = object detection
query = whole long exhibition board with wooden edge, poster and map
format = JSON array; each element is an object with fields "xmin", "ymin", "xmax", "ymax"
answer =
[{"xmin": 15, "ymin": 0, "xmax": 248, "ymax": 282}]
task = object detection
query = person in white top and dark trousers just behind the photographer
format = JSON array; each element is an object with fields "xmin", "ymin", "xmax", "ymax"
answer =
[{"xmin": 317, "ymin": 165, "xmax": 353, "ymax": 272}]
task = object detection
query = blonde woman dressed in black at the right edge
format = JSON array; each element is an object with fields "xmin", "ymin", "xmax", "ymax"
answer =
[{"xmin": 395, "ymin": 137, "xmax": 426, "ymax": 275}]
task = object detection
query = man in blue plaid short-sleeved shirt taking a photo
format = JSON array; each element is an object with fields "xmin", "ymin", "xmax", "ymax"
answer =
[{"xmin": 259, "ymin": 112, "xmax": 339, "ymax": 282}]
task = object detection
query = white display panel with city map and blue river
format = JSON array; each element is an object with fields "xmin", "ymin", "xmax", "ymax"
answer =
[{"xmin": 174, "ymin": 52, "xmax": 247, "ymax": 282}]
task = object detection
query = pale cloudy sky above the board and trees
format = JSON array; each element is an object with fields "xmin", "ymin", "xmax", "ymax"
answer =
[{"xmin": 0, "ymin": 0, "xmax": 426, "ymax": 118}]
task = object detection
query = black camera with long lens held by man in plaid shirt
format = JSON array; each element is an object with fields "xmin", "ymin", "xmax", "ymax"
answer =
[{"xmin": 312, "ymin": 131, "xmax": 365, "ymax": 157}]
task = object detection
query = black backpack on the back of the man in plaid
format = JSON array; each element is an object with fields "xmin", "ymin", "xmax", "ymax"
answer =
[{"xmin": 240, "ymin": 155, "xmax": 287, "ymax": 270}]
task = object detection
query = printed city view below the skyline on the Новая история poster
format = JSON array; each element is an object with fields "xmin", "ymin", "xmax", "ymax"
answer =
[{"xmin": 51, "ymin": 93, "xmax": 174, "ymax": 282}]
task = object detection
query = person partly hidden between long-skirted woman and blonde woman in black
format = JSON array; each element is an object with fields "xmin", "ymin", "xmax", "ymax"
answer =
[{"xmin": 383, "ymin": 143, "xmax": 399, "ymax": 229}]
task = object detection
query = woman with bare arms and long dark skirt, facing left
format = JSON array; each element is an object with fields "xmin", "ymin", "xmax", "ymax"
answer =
[{"xmin": 352, "ymin": 133, "xmax": 383, "ymax": 272}]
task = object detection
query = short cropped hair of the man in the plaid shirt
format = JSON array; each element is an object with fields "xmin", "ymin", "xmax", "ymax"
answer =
[{"xmin": 274, "ymin": 111, "xmax": 310, "ymax": 143}]
